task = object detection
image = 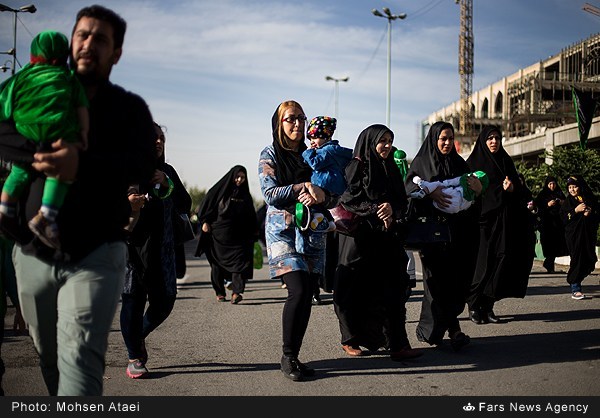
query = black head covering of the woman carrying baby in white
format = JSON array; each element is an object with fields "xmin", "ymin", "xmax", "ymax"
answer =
[{"xmin": 404, "ymin": 122, "xmax": 469, "ymax": 193}]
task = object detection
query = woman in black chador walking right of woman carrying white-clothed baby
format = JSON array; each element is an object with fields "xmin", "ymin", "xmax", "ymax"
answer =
[{"xmin": 467, "ymin": 126, "xmax": 535, "ymax": 324}]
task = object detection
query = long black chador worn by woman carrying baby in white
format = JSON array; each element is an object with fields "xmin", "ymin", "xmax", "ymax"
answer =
[{"xmin": 405, "ymin": 122, "xmax": 479, "ymax": 345}]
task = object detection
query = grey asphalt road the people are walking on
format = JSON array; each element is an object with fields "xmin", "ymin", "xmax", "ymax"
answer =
[{"xmin": 2, "ymin": 242, "xmax": 600, "ymax": 397}]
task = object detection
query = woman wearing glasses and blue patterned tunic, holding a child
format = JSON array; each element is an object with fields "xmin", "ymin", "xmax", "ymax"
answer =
[{"xmin": 258, "ymin": 100, "xmax": 335, "ymax": 381}]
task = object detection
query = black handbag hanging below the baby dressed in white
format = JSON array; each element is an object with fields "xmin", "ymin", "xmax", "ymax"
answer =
[{"xmin": 404, "ymin": 216, "xmax": 452, "ymax": 249}]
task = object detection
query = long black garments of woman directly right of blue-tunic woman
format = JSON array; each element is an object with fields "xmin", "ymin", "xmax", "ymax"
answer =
[{"xmin": 333, "ymin": 125, "xmax": 409, "ymax": 352}]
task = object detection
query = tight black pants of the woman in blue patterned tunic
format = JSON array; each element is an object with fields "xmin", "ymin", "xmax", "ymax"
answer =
[{"xmin": 281, "ymin": 271, "xmax": 315, "ymax": 357}]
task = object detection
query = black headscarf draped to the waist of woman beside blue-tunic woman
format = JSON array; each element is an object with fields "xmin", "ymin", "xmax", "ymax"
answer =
[{"xmin": 341, "ymin": 124, "xmax": 406, "ymax": 215}]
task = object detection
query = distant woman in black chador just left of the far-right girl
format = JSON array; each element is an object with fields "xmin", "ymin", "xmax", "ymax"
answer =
[{"xmin": 535, "ymin": 176, "xmax": 567, "ymax": 273}]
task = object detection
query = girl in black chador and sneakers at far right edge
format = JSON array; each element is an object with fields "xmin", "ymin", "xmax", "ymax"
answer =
[{"xmin": 560, "ymin": 175, "xmax": 600, "ymax": 300}]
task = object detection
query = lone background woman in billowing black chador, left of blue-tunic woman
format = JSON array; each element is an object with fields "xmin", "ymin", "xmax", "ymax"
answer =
[{"xmin": 195, "ymin": 165, "xmax": 258, "ymax": 304}]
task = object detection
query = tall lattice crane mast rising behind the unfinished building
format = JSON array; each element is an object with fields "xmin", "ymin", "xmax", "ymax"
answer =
[{"xmin": 456, "ymin": 0, "xmax": 474, "ymax": 144}]
